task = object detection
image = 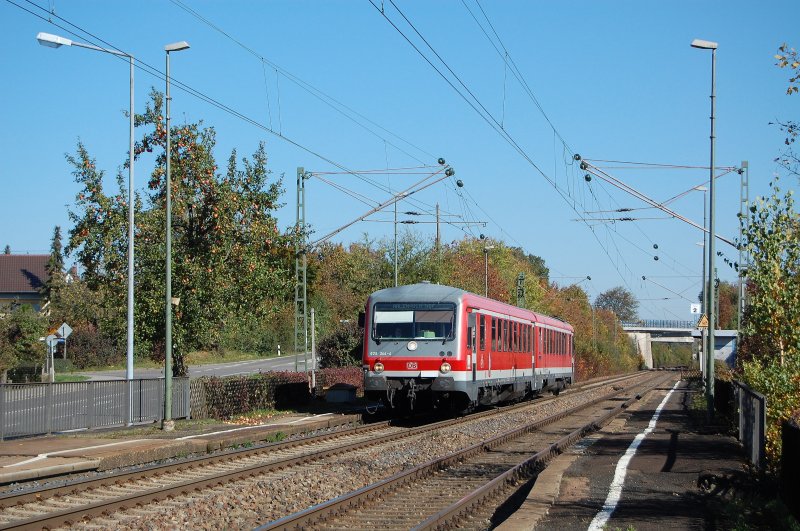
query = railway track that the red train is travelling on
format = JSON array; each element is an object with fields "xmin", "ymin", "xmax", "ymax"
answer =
[{"xmin": 0, "ymin": 376, "xmax": 641, "ymax": 529}]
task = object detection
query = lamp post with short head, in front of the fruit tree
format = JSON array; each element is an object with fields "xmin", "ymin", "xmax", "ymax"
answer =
[{"xmin": 162, "ymin": 41, "xmax": 189, "ymax": 431}]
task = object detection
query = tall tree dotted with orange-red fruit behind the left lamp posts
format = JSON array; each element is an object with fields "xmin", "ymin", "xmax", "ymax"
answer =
[{"xmin": 62, "ymin": 91, "xmax": 294, "ymax": 365}]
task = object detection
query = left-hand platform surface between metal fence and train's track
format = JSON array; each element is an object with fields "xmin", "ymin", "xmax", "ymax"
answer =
[{"xmin": 0, "ymin": 413, "xmax": 360, "ymax": 485}]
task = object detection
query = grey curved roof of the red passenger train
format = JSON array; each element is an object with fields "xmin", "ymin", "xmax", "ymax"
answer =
[{"xmin": 370, "ymin": 282, "xmax": 573, "ymax": 331}]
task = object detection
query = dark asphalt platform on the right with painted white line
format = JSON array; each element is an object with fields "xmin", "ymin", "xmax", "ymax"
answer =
[{"xmin": 497, "ymin": 381, "xmax": 745, "ymax": 531}]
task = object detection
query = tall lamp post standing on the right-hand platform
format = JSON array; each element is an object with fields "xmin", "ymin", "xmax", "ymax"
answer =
[{"xmin": 692, "ymin": 39, "xmax": 718, "ymax": 419}]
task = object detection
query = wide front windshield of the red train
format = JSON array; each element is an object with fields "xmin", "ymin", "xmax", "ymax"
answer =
[{"xmin": 372, "ymin": 302, "xmax": 456, "ymax": 342}]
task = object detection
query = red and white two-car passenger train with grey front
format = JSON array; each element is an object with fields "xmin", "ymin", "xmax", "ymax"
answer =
[{"xmin": 363, "ymin": 282, "xmax": 575, "ymax": 411}]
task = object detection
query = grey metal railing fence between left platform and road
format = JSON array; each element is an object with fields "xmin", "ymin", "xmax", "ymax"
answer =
[{"xmin": 0, "ymin": 378, "xmax": 190, "ymax": 440}]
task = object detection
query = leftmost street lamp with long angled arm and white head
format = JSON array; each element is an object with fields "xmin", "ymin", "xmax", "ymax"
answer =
[{"xmin": 36, "ymin": 32, "xmax": 134, "ymax": 390}]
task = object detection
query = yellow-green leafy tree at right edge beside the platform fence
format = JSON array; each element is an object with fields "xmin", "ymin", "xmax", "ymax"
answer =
[{"xmin": 737, "ymin": 44, "xmax": 800, "ymax": 470}]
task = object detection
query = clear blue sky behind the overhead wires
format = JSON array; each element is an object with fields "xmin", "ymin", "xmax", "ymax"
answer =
[{"xmin": 0, "ymin": 0, "xmax": 800, "ymax": 319}]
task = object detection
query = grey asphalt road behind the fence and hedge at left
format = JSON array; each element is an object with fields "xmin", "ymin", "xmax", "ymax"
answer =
[{"xmin": 79, "ymin": 355, "xmax": 311, "ymax": 380}]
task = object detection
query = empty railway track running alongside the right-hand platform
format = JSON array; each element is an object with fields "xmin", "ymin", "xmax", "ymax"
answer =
[{"xmin": 258, "ymin": 375, "xmax": 673, "ymax": 530}]
